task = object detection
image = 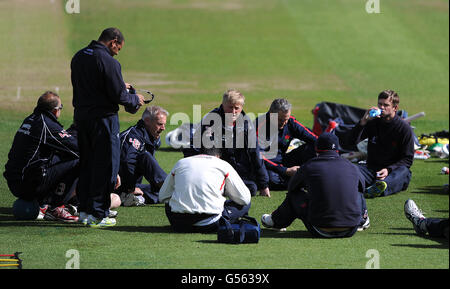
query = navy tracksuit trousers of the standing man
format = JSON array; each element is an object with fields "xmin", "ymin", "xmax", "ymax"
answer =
[{"xmin": 77, "ymin": 114, "xmax": 120, "ymax": 218}]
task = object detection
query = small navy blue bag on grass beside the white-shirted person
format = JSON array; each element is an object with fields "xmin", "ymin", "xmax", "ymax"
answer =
[{"xmin": 217, "ymin": 216, "xmax": 261, "ymax": 244}]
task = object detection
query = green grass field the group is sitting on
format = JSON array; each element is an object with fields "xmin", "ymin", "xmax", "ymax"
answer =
[{"xmin": 0, "ymin": 0, "xmax": 449, "ymax": 269}]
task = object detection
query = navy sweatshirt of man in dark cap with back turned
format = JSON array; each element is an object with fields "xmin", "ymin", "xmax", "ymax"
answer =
[{"xmin": 288, "ymin": 151, "xmax": 364, "ymax": 228}]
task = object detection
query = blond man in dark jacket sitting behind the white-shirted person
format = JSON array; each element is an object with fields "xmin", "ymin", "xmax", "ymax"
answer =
[{"xmin": 185, "ymin": 89, "xmax": 270, "ymax": 197}]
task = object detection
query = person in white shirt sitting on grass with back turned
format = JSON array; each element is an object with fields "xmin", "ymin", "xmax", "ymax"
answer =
[{"xmin": 159, "ymin": 149, "xmax": 251, "ymax": 233}]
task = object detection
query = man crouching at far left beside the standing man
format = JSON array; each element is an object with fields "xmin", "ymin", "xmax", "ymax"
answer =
[{"xmin": 3, "ymin": 91, "xmax": 79, "ymax": 222}]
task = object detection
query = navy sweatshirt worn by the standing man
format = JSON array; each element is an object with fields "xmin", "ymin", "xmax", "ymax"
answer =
[{"xmin": 70, "ymin": 40, "xmax": 139, "ymax": 121}]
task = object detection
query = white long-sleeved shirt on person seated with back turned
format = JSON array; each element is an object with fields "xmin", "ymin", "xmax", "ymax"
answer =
[{"xmin": 159, "ymin": 155, "xmax": 251, "ymax": 214}]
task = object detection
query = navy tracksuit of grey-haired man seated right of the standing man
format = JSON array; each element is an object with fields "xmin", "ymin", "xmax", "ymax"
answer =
[{"xmin": 119, "ymin": 120, "xmax": 167, "ymax": 204}]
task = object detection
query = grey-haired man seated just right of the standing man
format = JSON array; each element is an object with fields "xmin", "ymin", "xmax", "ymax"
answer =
[{"xmin": 117, "ymin": 106, "xmax": 169, "ymax": 206}]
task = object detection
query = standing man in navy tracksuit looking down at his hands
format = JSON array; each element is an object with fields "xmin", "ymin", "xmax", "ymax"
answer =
[{"xmin": 71, "ymin": 28, "xmax": 144, "ymax": 228}]
